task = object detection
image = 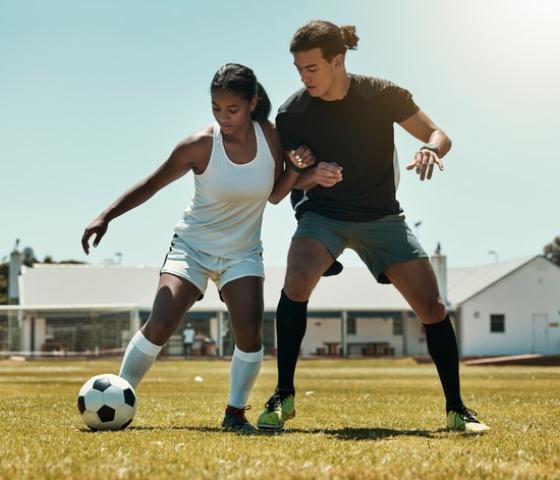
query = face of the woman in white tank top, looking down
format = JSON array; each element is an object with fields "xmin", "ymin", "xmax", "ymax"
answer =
[{"xmin": 212, "ymin": 90, "xmax": 258, "ymax": 134}]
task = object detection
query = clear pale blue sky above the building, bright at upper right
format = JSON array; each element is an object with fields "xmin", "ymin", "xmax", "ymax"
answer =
[{"xmin": 0, "ymin": 0, "xmax": 560, "ymax": 266}]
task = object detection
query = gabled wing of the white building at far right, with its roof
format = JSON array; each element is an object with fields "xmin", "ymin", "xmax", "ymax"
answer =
[{"xmin": 448, "ymin": 256, "xmax": 560, "ymax": 355}]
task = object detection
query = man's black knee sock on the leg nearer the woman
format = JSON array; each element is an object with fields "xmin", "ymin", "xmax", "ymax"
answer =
[{"xmin": 276, "ymin": 290, "xmax": 307, "ymax": 398}]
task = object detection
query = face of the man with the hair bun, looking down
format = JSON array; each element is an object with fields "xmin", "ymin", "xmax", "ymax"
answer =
[{"xmin": 293, "ymin": 48, "xmax": 341, "ymax": 97}]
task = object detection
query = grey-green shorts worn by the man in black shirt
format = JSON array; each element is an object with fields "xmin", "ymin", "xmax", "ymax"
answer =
[{"xmin": 292, "ymin": 212, "xmax": 428, "ymax": 283}]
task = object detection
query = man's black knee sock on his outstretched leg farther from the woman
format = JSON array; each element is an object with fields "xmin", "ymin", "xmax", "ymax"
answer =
[{"xmin": 424, "ymin": 315, "xmax": 463, "ymax": 411}]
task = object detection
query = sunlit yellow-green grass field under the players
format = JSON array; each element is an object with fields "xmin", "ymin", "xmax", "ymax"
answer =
[{"xmin": 0, "ymin": 359, "xmax": 560, "ymax": 480}]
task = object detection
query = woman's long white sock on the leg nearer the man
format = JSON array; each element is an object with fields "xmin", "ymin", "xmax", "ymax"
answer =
[{"xmin": 228, "ymin": 346, "xmax": 263, "ymax": 408}]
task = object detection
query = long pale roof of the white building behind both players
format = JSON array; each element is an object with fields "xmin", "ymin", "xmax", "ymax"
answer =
[{"xmin": 13, "ymin": 256, "xmax": 540, "ymax": 311}]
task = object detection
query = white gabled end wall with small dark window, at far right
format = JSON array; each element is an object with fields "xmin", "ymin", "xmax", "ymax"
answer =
[{"xmin": 461, "ymin": 257, "xmax": 560, "ymax": 355}]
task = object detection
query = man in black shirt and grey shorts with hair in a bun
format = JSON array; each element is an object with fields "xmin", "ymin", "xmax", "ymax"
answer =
[{"xmin": 257, "ymin": 21, "xmax": 488, "ymax": 432}]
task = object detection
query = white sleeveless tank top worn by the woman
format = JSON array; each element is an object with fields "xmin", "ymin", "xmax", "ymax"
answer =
[{"xmin": 175, "ymin": 122, "xmax": 275, "ymax": 259}]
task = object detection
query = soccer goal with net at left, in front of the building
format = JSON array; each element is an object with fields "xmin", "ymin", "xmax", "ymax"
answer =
[{"xmin": 0, "ymin": 305, "xmax": 141, "ymax": 357}]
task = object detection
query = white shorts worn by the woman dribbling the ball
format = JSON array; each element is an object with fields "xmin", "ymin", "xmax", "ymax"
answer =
[{"xmin": 160, "ymin": 235, "xmax": 264, "ymax": 300}]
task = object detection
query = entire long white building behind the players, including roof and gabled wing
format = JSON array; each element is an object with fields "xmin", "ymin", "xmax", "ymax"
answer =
[{"xmin": 0, "ymin": 256, "xmax": 560, "ymax": 356}]
